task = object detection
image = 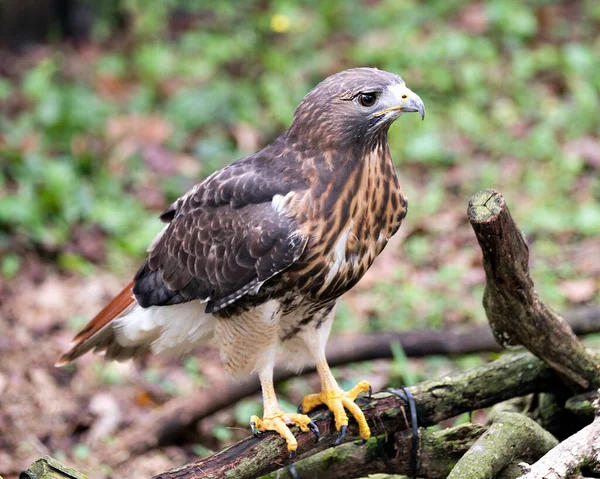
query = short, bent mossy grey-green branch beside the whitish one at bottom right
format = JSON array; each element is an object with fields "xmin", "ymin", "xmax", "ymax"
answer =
[{"xmin": 448, "ymin": 412, "xmax": 558, "ymax": 479}]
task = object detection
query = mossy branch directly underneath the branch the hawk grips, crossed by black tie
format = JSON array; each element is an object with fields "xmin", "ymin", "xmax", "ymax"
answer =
[{"xmin": 262, "ymin": 423, "xmax": 485, "ymax": 479}]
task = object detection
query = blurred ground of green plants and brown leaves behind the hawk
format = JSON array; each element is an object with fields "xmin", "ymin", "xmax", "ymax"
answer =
[{"xmin": 0, "ymin": 0, "xmax": 600, "ymax": 478}]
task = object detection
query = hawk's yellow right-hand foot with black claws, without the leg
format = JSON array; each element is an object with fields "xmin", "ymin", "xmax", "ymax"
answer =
[{"xmin": 302, "ymin": 381, "xmax": 371, "ymax": 439}]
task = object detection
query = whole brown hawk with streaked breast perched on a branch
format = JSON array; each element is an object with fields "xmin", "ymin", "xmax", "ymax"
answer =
[{"xmin": 57, "ymin": 68, "xmax": 425, "ymax": 454}]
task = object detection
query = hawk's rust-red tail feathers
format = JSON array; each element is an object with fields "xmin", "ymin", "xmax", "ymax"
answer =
[{"xmin": 55, "ymin": 281, "xmax": 135, "ymax": 366}]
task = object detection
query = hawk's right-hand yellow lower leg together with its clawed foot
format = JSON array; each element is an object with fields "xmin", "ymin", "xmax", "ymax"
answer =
[{"xmin": 300, "ymin": 354, "xmax": 371, "ymax": 446}]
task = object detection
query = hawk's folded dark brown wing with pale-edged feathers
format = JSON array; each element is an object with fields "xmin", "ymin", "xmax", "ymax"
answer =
[{"xmin": 133, "ymin": 145, "xmax": 307, "ymax": 313}]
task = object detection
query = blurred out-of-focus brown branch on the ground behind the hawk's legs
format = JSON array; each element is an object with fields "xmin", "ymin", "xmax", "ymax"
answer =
[{"xmin": 116, "ymin": 306, "xmax": 600, "ymax": 464}]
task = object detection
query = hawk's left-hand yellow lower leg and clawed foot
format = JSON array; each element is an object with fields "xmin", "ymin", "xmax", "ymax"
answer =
[{"xmin": 250, "ymin": 367, "xmax": 319, "ymax": 457}]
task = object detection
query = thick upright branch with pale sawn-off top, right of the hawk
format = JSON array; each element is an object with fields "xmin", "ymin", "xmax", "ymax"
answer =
[{"xmin": 468, "ymin": 190, "xmax": 600, "ymax": 389}]
